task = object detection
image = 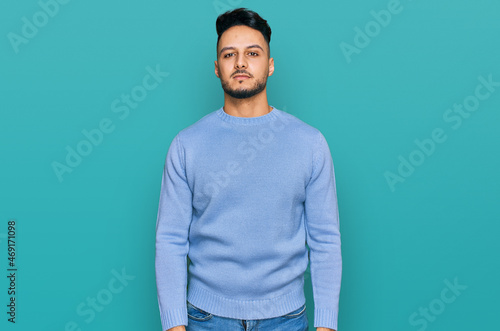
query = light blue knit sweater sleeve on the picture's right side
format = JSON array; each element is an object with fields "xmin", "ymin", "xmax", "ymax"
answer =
[{"xmin": 304, "ymin": 132, "xmax": 342, "ymax": 330}]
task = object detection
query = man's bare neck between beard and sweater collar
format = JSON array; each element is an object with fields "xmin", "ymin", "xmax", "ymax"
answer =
[{"xmin": 224, "ymin": 90, "xmax": 272, "ymax": 117}]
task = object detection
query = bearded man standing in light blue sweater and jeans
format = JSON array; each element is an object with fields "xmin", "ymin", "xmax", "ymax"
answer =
[{"xmin": 155, "ymin": 8, "xmax": 342, "ymax": 331}]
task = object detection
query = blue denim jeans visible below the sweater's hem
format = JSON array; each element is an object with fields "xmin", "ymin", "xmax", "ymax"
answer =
[{"xmin": 186, "ymin": 301, "xmax": 309, "ymax": 331}]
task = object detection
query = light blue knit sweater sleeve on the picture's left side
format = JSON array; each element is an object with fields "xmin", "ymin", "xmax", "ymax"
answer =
[{"xmin": 155, "ymin": 135, "xmax": 193, "ymax": 330}]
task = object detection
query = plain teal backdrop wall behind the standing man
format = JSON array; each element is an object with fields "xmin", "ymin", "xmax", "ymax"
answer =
[{"xmin": 0, "ymin": 0, "xmax": 500, "ymax": 331}]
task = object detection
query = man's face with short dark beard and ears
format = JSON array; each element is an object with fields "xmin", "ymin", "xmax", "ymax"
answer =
[{"xmin": 215, "ymin": 25, "xmax": 274, "ymax": 99}]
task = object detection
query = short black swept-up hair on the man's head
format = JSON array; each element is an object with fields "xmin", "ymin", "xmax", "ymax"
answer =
[{"xmin": 215, "ymin": 8, "xmax": 271, "ymax": 56}]
